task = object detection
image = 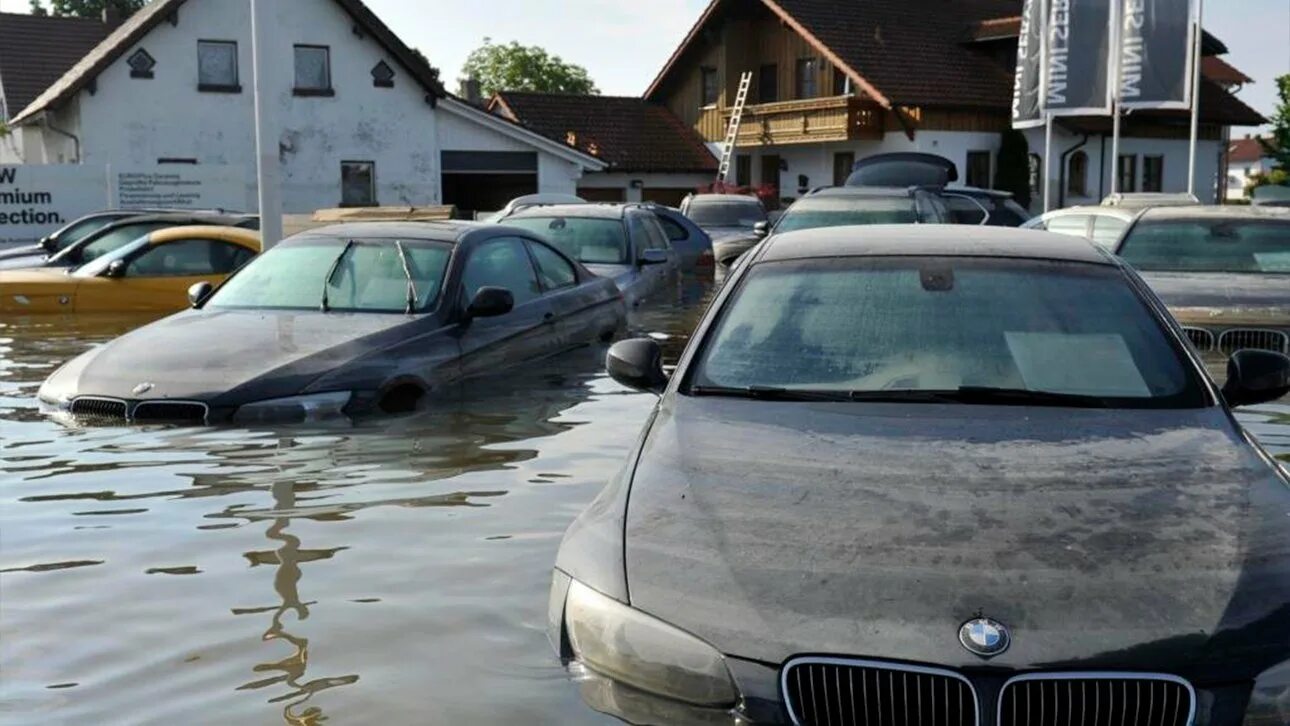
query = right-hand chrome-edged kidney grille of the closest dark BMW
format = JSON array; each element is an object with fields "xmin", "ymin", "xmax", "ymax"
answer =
[{"xmin": 998, "ymin": 673, "xmax": 1196, "ymax": 726}]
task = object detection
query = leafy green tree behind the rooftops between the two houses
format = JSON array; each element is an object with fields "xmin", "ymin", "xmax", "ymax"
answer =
[{"xmin": 462, "ymin": 37, "xmax": 600, "ymax": 95}]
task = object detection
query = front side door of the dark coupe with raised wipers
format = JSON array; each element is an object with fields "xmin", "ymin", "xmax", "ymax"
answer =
[{"xmin": 455, "ymin": 237, "xmax": 561, "ymax": 378}]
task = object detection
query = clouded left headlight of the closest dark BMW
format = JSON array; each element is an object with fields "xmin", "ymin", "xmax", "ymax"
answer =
[{"xmin": 565, "ymin": 580, "xmax": 738, "ymax": 707}]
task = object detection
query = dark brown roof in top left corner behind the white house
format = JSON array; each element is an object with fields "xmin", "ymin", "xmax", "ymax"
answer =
[{"xmin": 0, "ymin": 13, "xmax": 114, "ymax": 116}]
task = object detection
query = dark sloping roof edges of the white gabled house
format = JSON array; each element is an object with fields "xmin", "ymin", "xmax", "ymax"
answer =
[{"xmin": 8, "ymin": 0, "xmax": 445, "ymax": 123}]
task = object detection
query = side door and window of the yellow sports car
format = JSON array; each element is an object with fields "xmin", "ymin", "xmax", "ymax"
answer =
[{"xmin": 76, "ymin": 237, "xmax": 255, "ymax": 312}]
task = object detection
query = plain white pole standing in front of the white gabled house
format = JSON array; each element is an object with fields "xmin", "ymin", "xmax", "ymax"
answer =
[{"xmin": 250, "ymin": 0, "xmax": 283, "ymax": 250}]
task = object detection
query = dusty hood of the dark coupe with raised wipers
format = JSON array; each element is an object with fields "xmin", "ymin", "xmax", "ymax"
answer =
[{"xmin": 46, "ymin": 311, "xmax": 420, "ymax": 405}]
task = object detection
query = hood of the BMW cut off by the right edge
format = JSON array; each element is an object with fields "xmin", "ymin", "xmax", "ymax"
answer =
[{"xmin": 1142, "ymin": 272, "xmax": 1290, "ymax": 316}]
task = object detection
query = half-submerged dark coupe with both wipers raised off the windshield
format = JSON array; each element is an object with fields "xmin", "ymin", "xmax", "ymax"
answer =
[{"xmin": 40, "ymin": 223, "xmax": 626, "ymax": 422}]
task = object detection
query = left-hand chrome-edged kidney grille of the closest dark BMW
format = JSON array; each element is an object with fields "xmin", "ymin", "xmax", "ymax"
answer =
[{"xmin": 780, "ymin": 658, "xmax": 978, "ymax": 726}]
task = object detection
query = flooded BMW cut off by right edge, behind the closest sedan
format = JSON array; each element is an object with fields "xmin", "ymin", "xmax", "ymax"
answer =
[{"xmin": 1116, "ymin": 206, "xmax": 1290, "ymax": 370}]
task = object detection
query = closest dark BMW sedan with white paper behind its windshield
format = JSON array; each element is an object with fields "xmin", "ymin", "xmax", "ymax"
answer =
[{"xmin": 548, "ymin": 226, "xmax": 1290, "ymax": 726}]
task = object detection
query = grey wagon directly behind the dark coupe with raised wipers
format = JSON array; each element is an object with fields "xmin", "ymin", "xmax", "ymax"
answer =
[{"xmin": 502, "ymin": 204, "xmax": 681, "ymax": 307}]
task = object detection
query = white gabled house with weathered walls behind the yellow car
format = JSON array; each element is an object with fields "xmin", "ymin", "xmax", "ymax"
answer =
[{"xmin": 0, "ymin": 0, "xmax": 605, "ymax": 213}]
